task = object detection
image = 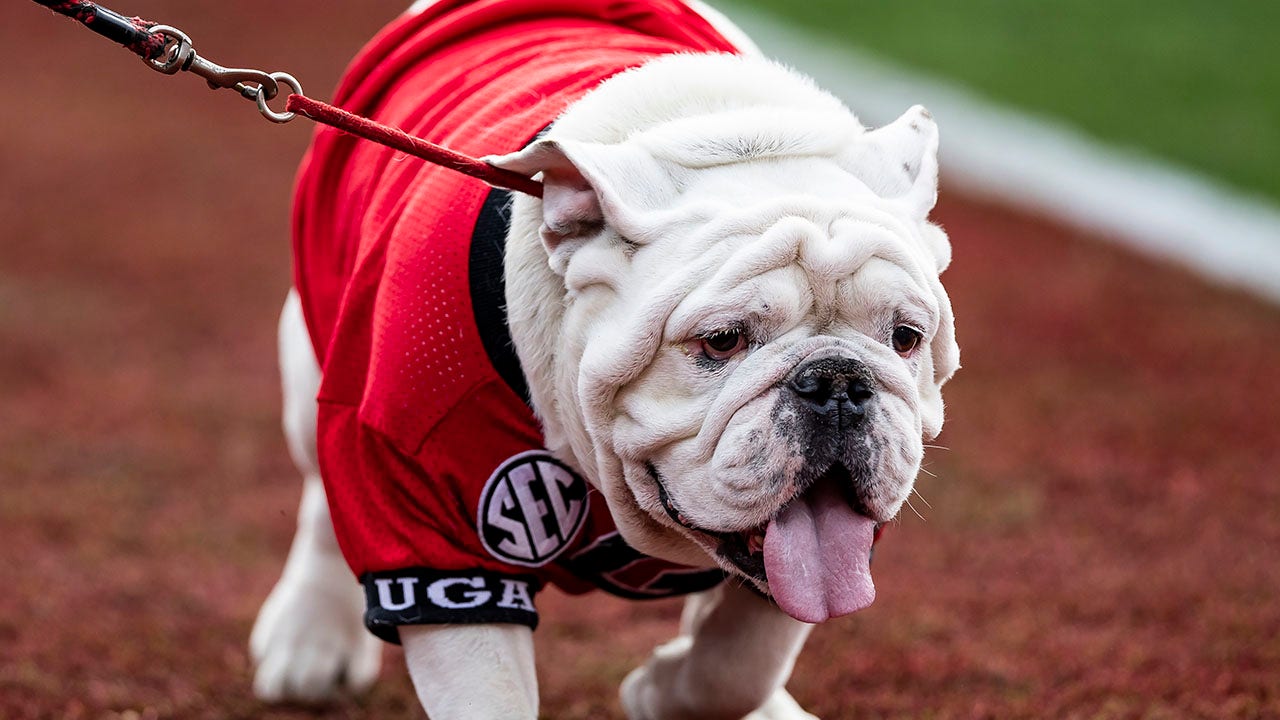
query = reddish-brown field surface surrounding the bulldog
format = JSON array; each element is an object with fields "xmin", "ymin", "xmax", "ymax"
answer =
[{"xmin": 0, "ymin": 0, "xmax": 1280, "ymax": 720}]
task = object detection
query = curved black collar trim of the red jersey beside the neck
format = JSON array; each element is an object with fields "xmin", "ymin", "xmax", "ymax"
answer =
[{"xmin": 467, "ymin": 188, "xmax": 530, "ymax": 405}]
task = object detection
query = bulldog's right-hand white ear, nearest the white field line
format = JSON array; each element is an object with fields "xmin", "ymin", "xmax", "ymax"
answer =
[{"xmin": 841, "ymin": 105, "xmax": 938, "ymax": 220}]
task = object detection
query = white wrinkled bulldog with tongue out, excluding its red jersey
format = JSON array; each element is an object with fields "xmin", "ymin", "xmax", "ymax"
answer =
[{"xmin": 251, "ymin": 2, "xmax": 959, "ymax": 720}]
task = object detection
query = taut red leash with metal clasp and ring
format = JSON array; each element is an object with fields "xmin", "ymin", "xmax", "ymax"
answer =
[{"xmin": 35, "ymin": 0, "xmax": 543, "ymax": 197}]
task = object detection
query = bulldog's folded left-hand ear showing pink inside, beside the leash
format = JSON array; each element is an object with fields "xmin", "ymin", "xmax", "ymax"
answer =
[{"xmin": 485, "ymin": 140, "xmax": 673, "ymax": 273}]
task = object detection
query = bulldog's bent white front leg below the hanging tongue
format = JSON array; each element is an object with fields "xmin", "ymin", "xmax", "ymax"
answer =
[{"xmin": 621, "ymin": 580, "xmax": 813, "ymax": 720}]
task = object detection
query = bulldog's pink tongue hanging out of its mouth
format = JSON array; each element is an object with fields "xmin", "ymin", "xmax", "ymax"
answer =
[{"xmin": 764, "ymin": 482, "xmax": 876, "ymax": 623}]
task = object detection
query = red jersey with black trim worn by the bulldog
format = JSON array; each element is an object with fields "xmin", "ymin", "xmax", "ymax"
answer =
[{"xmin": 285, "ymin": 0, "xmax": 733, "ymax": 642}]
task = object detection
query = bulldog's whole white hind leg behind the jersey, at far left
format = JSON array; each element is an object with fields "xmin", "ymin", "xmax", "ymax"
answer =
[{"xmin": 250, "ymin": 292, "xmax": 381, "ymax": 702}]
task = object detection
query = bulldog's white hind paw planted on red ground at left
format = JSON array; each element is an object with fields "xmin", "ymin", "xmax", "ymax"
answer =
[{"xmin": 250, "ymin": 548, "xmax": 381, "ymax": 702}]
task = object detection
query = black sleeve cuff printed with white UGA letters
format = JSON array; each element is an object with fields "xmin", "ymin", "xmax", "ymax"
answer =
[{"xmin": 360, "ymin": 568, "xmax": 541, "ymax": 644}]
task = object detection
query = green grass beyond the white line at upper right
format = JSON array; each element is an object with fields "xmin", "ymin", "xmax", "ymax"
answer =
[{"xmin": 732, "ymin": 0, "xmax": 1280, "ymax": 200}]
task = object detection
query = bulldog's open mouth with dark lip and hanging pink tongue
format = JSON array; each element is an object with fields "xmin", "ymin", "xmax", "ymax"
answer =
[{"xmin": 645, "ymin": 462, "xmax": 883, "ymax": 623}]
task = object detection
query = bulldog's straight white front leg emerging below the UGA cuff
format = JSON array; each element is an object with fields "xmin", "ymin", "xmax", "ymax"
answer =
[{"xmin": 401, "ymin": 624, "xmax": 538, "ymax": 720}]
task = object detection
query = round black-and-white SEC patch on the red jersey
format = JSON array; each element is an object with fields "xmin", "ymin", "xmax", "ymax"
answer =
[{"xmin": 476, "ymin": 450, "xmax": 589, "ymax": 568}]
